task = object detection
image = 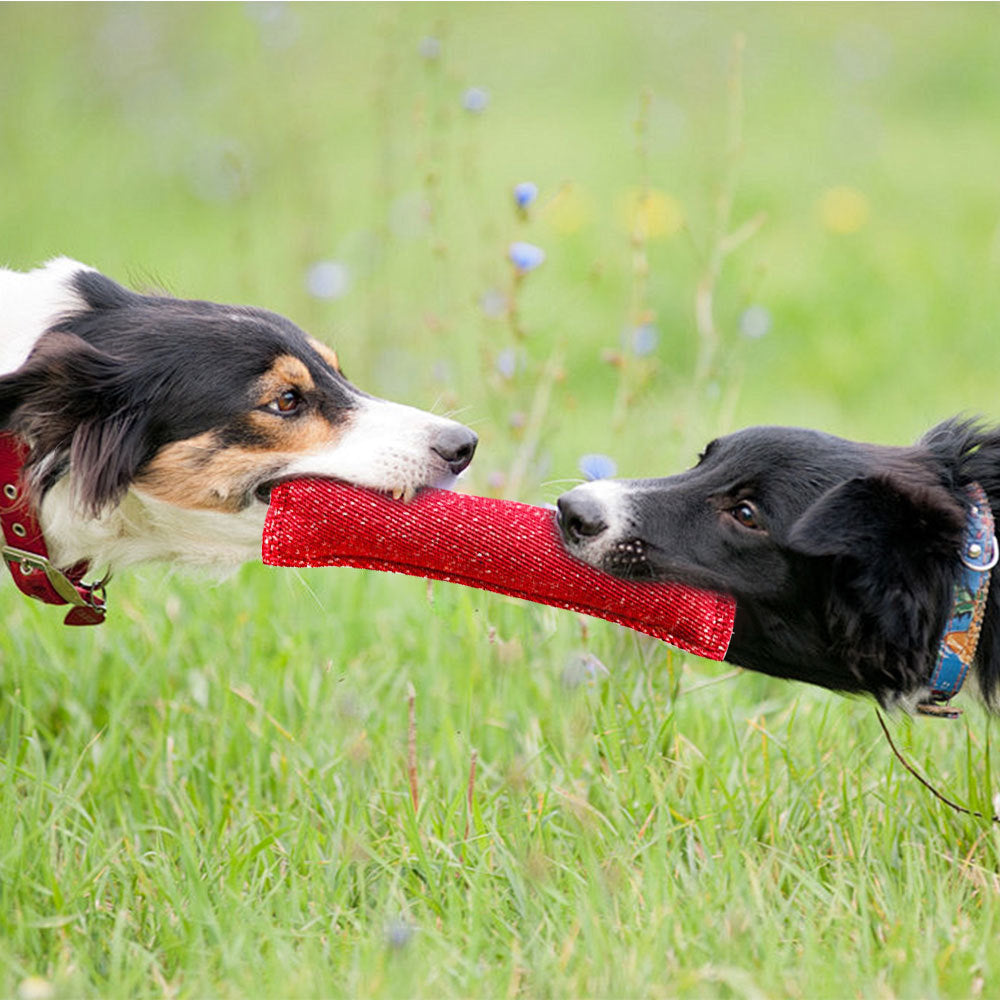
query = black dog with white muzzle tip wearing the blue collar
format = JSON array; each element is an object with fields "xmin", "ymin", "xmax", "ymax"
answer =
[{"xmin": 558, "ymin": 420, "xmax": 1000, "ymax": 707}]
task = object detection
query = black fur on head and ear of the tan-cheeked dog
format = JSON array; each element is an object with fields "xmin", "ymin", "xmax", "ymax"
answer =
[{"xmin": 0, "ymin": 271, "xmax": 364, "ymax": 514}]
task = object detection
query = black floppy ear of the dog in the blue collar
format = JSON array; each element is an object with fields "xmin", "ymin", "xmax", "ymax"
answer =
[{"xmin": 788, "ymin": 469, "xmax": 964, "ymax": 651}]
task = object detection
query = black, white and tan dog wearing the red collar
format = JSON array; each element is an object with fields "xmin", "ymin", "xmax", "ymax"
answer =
[{"xmin": 0, "ymin": 258, "xmax": 476, "ymax": 569}]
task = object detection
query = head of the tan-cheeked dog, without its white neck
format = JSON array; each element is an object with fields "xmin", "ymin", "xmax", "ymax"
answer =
[{"xmin": 0, "ymin": 266, "xmax": 476, "ymax": 568}]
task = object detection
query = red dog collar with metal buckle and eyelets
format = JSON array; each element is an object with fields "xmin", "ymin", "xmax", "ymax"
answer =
[{"xmin": 0, "ymin": 432, "xmax": 107, "ymax": 625}]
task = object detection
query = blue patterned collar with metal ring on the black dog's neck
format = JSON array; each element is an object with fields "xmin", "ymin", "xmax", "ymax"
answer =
[{"xmin": 917, "ymin": 483, "xmax": 1000, "ymax": 719}]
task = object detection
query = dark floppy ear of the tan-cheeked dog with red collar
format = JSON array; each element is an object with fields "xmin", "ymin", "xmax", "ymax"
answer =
[{"xmin": 0, "ymin": 332, "xmax": 149, "ymax": 515}]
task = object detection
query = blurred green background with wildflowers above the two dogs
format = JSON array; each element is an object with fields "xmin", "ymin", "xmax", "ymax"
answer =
[{"xmin": 7, "ymin": 3, "xmax": 1000, "ymax": 501}]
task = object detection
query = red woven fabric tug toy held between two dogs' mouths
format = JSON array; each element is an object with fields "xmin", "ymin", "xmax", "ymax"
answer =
[{"xmin": 263, "ymin": 479, "xmax": 736, "ymax": 660}]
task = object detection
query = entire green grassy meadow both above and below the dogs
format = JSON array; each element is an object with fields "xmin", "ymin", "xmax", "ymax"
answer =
[{"xmin": 0, "ymin": 3, "xmax": 1000, "ymax": 1000}]
